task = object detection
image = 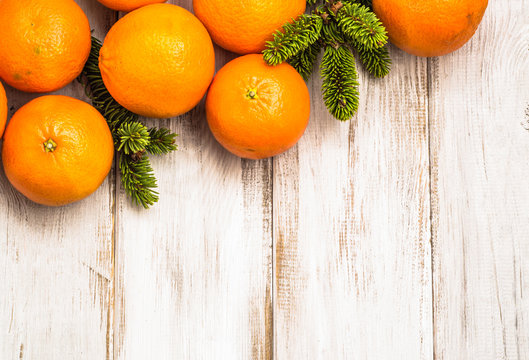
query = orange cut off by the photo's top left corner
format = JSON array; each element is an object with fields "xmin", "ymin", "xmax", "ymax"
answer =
[{"xmin": 0, "ymin": 0, "xmax": 91, "ymax": 92}]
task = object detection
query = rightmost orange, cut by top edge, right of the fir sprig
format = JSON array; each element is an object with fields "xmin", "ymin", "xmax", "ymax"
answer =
[{"xmin": 373, "ymin": 0, "xmax": 488, "ymax": 56}]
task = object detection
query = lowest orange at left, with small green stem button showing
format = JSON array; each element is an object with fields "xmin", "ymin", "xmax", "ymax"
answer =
[{"xmin": 2, "ymin": 95, "xmax": 114, "ymax": 206}]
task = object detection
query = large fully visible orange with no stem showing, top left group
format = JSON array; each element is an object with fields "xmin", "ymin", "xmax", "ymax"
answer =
[{"xmin": 99, "ymin": 4, "xmax": 215, "ymax": 118}]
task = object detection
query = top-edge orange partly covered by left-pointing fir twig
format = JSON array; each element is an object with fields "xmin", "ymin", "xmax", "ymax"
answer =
[{"xmin": 193, "ymin": 0, "xmax": 306, "ymax": 54}]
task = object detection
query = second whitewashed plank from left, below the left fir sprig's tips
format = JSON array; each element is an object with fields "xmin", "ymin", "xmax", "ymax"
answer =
[{"xmin": 115, "ymin": 0, "xmax": 272, "ymax": 359}]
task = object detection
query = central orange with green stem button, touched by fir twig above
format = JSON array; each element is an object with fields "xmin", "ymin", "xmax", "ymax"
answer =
[{"xmin": 206, "ymin": 55, "xmax": 310, "ymax": 159}]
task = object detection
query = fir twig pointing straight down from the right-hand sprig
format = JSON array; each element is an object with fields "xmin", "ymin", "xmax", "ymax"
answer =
[{"xmin": 321, "ymin": 45, "xmax": 360, "ymax": 121}]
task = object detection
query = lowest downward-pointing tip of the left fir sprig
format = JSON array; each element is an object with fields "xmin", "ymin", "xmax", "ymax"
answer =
[{"xmin": 119, "ymin": 153, "xmax": 159, "ymax": 209}]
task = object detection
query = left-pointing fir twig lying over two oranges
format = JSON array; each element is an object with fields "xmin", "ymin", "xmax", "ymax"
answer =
[{"xmin": 264, "ymin": 15, "xmax": 323, "ymax": 65}]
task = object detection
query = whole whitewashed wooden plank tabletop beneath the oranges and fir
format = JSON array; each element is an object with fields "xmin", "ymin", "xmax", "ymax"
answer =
[{"xmin": 0, "ymin": 0, "xmax": 529, "ymax": 360}]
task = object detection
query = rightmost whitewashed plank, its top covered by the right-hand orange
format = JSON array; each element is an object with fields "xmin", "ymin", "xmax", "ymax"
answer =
[{"xmin": 430, "ymin": 0, "xmax": 529, "ymax": 360}]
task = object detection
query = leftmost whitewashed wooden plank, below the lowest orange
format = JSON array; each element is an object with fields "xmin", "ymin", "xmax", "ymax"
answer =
[{"xmin": 0, "ymin": 0, "xmax": 114, "ymax": 360}]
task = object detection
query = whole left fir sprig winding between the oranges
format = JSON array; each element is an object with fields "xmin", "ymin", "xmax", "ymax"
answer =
[{"xmin": 80, "ymin": 37, "xmax": 177, "ymax": 208}]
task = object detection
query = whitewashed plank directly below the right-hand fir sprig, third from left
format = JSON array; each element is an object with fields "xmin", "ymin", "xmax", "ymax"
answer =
[{"xmin": 273, "ymin": 49, "xmax": 433, "ymax": 360}]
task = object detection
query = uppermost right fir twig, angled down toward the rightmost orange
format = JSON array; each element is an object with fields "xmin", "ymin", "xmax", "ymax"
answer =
[{"xmin": 336, "ymin": 4, "xmax": 388, "ymax": 50}]
